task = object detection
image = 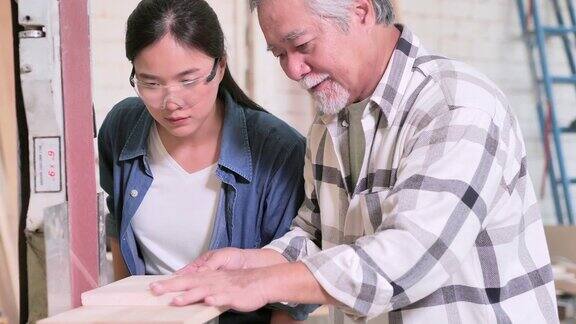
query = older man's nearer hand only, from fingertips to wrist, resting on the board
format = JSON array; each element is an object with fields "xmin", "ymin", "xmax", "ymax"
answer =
[{"xmin": 150, "ymin": 268, "xmax": 269, "ymax": 312}]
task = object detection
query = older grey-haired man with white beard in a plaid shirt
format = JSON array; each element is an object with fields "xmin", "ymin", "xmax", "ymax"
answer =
[{"xmin": 152, "ymin": 0, "xmax": 558, "ymax": 323}]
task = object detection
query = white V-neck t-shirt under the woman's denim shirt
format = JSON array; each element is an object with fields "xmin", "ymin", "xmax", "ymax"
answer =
[{"xmin": 132, "ymin": 125, "xmax": 221, "ymax": 274}]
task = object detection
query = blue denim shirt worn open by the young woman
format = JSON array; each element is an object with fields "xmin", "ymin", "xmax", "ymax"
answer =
[{"xmin": 98, "ymin": 91, "xmax": 316, "ymax": 318}]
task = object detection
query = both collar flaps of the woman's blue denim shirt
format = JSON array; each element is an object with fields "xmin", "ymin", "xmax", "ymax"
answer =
[{"xmin": 119, "ymin": 90, "xmax": 253, "ymax": 182}]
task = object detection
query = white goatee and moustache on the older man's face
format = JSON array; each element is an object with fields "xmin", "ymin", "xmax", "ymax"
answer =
[{"xmin": 299, "ymin": 73, "xmax": 350, "ymax": 115}]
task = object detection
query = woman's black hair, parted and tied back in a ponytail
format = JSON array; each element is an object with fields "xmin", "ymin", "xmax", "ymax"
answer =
[{"xmin": 126, "ymin": 0, "xmax": 264, "ymax": 111}]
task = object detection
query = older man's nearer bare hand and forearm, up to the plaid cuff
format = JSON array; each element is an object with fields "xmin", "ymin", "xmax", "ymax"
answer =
[{"xmin": 150, "ymin": 260, "xmax": 335, "ymax": 312}]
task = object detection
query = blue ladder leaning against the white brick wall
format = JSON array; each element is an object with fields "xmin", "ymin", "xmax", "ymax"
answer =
[{"xmin": 516, "ymin": 0, "xmax": 576, "ymax": 225}]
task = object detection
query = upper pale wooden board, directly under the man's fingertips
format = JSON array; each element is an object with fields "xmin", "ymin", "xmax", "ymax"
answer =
[{"xmin": 82, "ymin": 275, "xmax": 178, "ymax": 306}]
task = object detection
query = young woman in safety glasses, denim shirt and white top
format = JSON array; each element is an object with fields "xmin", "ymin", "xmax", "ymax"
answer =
[{"xmin": 98, "ymin": 0, "xmax": 305, "ymax": 323}]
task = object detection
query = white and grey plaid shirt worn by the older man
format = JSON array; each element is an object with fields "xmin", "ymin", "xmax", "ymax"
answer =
[{"xmin": 267, "ymin": 25, "xmax": 558, "ymax": 323}]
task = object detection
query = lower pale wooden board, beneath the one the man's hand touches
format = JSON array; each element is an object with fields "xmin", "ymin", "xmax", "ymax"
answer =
[{"xmin": 38, "ymin": 304, "xmax": 224, "ymax": 324}]
